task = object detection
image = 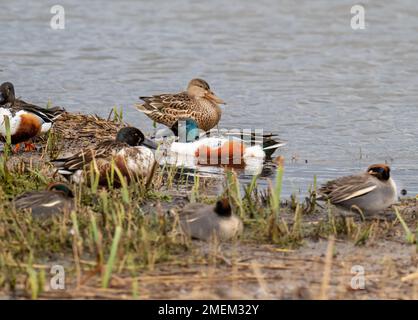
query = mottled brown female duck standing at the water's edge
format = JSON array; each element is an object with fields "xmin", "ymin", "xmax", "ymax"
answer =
[{"xmin": 136, "ymin": 79, "xmax": 226, "ymax": 131}]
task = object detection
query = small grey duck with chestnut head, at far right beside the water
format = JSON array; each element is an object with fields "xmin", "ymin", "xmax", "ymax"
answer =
[{"xmin": 318, "ymin": 164, "xmax": 397, "ymax": 214}]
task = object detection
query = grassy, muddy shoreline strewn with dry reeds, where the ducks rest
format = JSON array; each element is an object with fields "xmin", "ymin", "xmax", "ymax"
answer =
[{"xmin": 0, "ymin": 110, "xmax": 418, "ymax": 299}]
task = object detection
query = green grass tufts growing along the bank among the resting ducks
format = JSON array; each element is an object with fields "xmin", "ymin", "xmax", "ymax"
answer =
[{"xmin": 0, "ymin": 120, "xmax": 418, "ymax": 299}]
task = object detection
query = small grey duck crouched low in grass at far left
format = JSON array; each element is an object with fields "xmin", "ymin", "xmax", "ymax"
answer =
[{"xmin": 13, "ymin": 182, "xmax": 74, "ymax": 218}]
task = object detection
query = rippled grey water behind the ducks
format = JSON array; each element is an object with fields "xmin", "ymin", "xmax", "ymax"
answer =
[{"xmin": 0, "ymin": 0, "xmax": 418, "ymax": 195}]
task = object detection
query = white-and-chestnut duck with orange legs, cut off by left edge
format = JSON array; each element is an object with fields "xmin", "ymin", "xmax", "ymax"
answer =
[{"xmin": 0, "ymin": 82, "xmax": 65, "ymax": 152}]
